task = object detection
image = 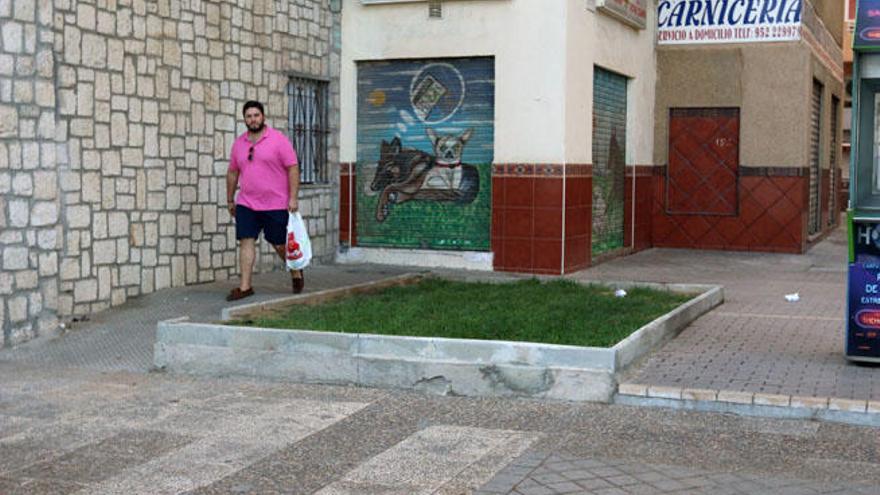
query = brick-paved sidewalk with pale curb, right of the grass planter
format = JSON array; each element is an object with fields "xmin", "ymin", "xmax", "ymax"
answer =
[{"xmin": 574, "ymin": 224, "xmax": 880, "ymax": 412}]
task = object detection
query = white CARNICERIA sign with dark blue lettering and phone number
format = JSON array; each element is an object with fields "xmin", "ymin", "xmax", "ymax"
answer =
[{"xmin": 657, "ymin": 0, "xmax": 803, "ymax": 45}]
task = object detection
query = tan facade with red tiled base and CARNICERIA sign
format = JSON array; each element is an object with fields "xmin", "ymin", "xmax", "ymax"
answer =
[{"xmin": 645, "ymin": 0, "xmax": 845, "ymax": 253}]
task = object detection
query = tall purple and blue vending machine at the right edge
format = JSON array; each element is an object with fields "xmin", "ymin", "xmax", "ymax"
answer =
[{"xmin": 846, "ymin": 0, "xmax": 880, "ymax": 362}]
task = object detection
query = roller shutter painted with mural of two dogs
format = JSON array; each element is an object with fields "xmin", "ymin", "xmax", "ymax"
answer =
[{"xmin": 357, "ymin": 57, "xmax": 495, "ymax": 251}]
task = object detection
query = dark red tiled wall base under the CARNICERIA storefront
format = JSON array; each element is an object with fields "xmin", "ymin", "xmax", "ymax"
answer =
[{"xmin": 651, "ymin": 167, "xmax": 808, "ymax": 253}]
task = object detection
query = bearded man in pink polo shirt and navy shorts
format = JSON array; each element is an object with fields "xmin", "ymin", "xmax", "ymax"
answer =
[{"xmin": 226, "ymin": 101, "xmax": 305, "ymax": 301}]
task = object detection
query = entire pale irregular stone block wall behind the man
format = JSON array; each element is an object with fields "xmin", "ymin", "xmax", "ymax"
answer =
[{"xmin": 0, "ymin": 0, "xmax": 339, "ymax": 346}]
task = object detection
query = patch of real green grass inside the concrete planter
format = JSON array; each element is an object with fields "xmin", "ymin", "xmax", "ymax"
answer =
[{"xmin": 242, "ymin": 279, "xmax": 692, "ymax": 347}]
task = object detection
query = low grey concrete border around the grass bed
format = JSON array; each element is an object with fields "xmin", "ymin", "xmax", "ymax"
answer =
[{"xmin": 154, "ymin": 275, "xmax": 723, "ymax": 402}]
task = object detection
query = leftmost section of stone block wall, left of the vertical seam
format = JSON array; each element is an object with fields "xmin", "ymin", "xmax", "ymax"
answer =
[{"xmin": 0, "ymin": 1, "xmax": 64, "ymax": 344}]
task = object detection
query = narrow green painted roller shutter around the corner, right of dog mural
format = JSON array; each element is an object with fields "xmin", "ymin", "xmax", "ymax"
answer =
[{"xmin": 592, "ymin": 67, "xmax": 627, "ymax": 258}]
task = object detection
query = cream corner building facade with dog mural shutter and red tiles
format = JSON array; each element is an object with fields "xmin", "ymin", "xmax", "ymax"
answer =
[{"xmin": 340, "ymin": 0, "xmax": 656, "ymax": 274}]
